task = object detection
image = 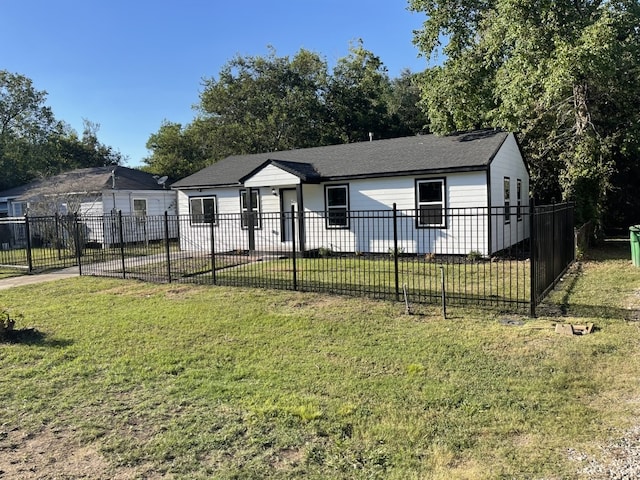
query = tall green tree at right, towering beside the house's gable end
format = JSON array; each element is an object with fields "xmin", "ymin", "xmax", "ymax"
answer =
[{"xmin": 409, "ymin": 0, "xmax": 640, "ymax": 229}]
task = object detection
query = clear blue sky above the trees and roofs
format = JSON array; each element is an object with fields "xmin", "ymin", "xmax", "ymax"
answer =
[{"xmin": 0, "ymin": 0, "xmax": 427, "ymax": 167}]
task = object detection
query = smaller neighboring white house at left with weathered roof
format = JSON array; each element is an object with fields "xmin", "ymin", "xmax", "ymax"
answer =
[{"xmin": 0, "ymin": 166, "xmax": 177, "ymax": 246}]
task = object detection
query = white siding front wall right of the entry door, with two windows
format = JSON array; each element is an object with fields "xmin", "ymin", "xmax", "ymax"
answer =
[{"xmin": 303, "ymin": 172, "xmax": 488, "ymax": 255}]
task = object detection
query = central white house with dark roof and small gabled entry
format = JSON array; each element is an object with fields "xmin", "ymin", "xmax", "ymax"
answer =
[{"xmin": 172, "ymin": 130, "xmax": 529, "ymax": 255}]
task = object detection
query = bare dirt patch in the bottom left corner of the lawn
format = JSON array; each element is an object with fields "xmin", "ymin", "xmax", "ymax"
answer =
[{"xmin": 0, "ymin": 428, "xmax": 160, "ymax": 480}]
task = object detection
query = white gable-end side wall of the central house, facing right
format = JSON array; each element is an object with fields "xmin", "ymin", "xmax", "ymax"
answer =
[{"xmin": 490, "ymin": 134, "xmax": 529, "ymax": 253}]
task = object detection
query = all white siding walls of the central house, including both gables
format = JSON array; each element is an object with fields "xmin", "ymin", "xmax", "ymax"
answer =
[{"xmin": 178, "ymin": 156, "xmax": 529, "ymax": 255}]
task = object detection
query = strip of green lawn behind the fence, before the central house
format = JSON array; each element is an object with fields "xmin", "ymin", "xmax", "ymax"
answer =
[{"xmin": 217, "ymin": 257, "xmax": 530, "ymax": 310}]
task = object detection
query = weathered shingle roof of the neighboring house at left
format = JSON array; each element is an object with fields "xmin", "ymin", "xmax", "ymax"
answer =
[{"xmin": 10, "ymin": 166, "xmax": 170, "ymax": 201}]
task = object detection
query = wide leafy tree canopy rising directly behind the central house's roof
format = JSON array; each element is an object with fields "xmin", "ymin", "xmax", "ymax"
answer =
[{"xmin": 144, "ymin": 42, "xmax": 426, "ymax": 178}]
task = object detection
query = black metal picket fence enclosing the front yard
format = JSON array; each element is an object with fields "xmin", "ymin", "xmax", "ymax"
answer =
[{"xmin": 0, "ymin": 204, "xmax": 575, "ymax": 315}]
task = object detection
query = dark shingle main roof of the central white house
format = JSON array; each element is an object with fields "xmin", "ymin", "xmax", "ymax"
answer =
[{"xmin": 173, "ymin": 130, "xmax": 508, "ymax": 188}]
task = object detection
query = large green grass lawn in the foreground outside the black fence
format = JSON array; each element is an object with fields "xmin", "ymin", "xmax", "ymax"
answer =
[{"xmin": 0, "ymin": 245, "xmax": 640, "ymax": 479}]
